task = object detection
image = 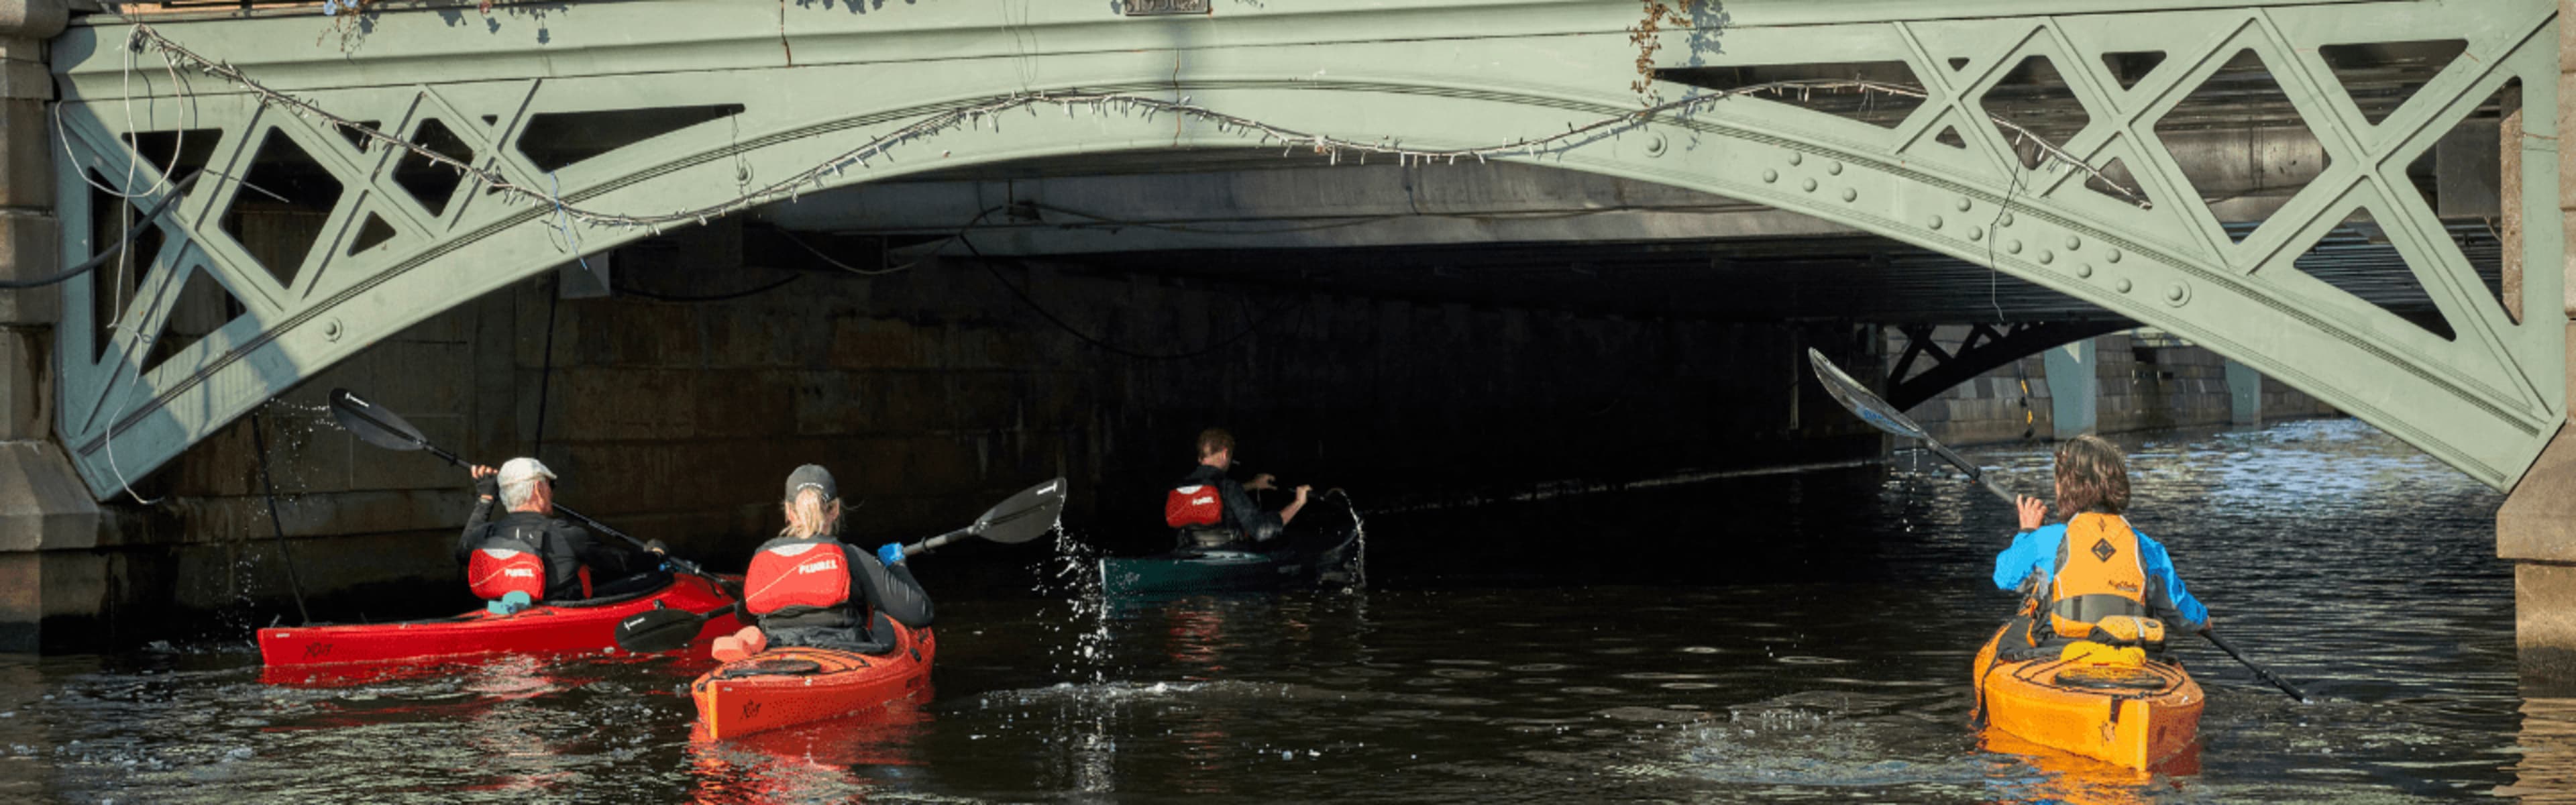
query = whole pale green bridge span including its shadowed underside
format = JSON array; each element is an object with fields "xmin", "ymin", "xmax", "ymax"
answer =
[{"xmin": 35, "ymin": 0, "xmax": 2566, "ymax": 498}]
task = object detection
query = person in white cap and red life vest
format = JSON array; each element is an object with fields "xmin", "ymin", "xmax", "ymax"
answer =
[{"xmin": 456, "ymin": 457, "xmax": 667, "ymax": 614}]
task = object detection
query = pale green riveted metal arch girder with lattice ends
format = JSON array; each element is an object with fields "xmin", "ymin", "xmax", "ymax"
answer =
[{"xmin": 56, "ymin": 0, "xmax": 2566, "ymax": 495}]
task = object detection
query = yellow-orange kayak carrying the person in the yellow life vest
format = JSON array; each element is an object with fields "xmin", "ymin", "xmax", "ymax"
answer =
[{"xmin": 1976, "ymin": 629, "xmax": 2205, "ymax": 769}]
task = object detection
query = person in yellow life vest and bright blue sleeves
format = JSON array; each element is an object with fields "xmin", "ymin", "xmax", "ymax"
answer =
[{"xmin": 1994, "ymin": 433, "xmax": 2210, "ymax": 658}]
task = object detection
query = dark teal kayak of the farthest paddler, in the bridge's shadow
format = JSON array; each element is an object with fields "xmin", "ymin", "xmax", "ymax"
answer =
[{"xmin": 1100, "ymin": 493, "xmax": 1360, "ymax": 596}]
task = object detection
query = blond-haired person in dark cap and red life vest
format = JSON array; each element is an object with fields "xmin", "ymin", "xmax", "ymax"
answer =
[{"xmin": 716, "ymin": 464, "xmax": 930, "ymax": 661}]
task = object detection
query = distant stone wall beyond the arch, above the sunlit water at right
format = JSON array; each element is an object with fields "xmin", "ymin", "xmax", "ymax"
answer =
[{"xmin": 1907, "ymin": 333, "xmax": 2337, "ymax": 444}]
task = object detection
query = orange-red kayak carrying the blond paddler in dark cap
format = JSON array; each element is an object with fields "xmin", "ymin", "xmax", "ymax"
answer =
[{"xmin": 688, "ymin": 625, "xmax": 941, "ymax": 741}]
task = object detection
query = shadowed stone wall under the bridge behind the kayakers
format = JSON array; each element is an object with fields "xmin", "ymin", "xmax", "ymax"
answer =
[{"xmin": 80, "ymin": 227, "xmax": 1880, "ymax": 640}]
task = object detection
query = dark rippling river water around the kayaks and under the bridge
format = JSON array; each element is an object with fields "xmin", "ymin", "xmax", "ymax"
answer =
[{"xmin": 0, "ymin": 421, "xmax": 2576, "ymax": 802}]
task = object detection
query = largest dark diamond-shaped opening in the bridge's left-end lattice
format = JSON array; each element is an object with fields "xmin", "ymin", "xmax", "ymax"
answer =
[{"xmin": 221, "ymin": 129, "xmax": 340, "ymax": 289}]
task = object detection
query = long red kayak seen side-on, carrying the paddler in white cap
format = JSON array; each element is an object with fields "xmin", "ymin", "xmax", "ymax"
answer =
[{"xmin": 260, "ymin": 576, "xmax": 742, "ymax": 668}]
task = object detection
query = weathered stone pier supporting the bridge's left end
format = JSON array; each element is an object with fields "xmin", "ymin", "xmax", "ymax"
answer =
[{"xmin": 0, "ymin": 0, "xmax": 98, "ymax": 650}]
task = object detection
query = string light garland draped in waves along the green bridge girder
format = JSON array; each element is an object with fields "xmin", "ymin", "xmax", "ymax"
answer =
[{"xmin": 111, "ymin": 25, "xmax": 2153, "ymax": 232}]
